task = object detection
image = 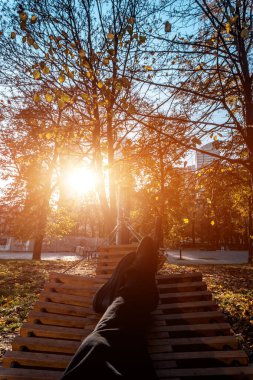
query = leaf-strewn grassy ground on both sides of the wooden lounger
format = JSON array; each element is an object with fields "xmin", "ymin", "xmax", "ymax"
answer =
[{"xmin": 0, "ymin": 260, "xmax": 253, "ymax": 362}]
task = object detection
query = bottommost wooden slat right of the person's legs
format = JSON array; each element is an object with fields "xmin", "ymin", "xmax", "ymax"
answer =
[{"xmin": 156, "ymin": 366, "xmax": 253, "ymax": 380}]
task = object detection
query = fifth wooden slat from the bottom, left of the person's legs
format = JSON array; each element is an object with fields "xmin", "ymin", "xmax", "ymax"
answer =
[{"xmin": 27, "ymin": 311, "xmax": 94, "ymax": 328}]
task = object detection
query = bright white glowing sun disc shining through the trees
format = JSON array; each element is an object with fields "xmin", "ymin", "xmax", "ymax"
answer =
[{"xmin": 64, "ymin": 167, "xmax": 98, "ymax": 196}]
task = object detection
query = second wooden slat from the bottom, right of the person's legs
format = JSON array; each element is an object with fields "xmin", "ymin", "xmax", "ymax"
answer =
[{"xmin": 150, "ymin": 350, "xmax": 248, "ymax": 368}]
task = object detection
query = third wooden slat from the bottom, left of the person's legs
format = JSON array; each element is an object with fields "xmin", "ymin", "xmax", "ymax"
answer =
[{"xmin": 12, "ymin": 336, "xmax": 81, "ymax": 355}]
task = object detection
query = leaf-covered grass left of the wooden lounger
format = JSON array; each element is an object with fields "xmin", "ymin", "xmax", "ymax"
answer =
[{"xmin": 0, "ymin": 260, "xmax": 73, "ymax": 362}]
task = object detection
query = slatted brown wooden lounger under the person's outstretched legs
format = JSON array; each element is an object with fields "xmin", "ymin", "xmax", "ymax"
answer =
[{"xmin": 0, "ymin": 247, "xmax": 253, "ymax": 380}]
